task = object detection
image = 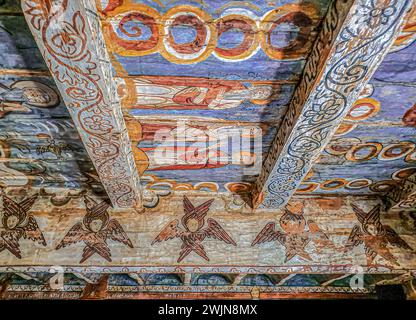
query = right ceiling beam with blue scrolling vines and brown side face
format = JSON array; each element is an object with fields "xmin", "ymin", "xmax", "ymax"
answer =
[{"xmin": 253, "ymin": 0, "xmax": 412, "ymax": 209}]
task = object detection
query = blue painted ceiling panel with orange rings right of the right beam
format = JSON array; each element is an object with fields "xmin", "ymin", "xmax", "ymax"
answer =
[{"xmin": 296, "ymin": 6, "xmax": 416, "ymax": 198}]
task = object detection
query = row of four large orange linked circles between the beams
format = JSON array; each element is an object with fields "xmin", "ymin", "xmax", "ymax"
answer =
[{"xmin": 103, "ymin": 4, "xmax": 318, "ymax": 64}]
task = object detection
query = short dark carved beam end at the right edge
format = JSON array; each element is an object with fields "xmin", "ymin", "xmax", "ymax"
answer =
[{"xmin": 385, "ymin": 173, "xmax": 416, "ymax": 210}]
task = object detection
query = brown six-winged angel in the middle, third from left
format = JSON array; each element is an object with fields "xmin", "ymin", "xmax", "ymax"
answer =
[{"xmin": 152, "ymin": 196, "xmax": 237, "ymax": 262}]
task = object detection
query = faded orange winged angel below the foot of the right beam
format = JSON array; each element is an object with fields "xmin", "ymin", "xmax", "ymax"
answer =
[{"xmin": 251, "ymin": 202, "xmax": 336, "ymax": 263}]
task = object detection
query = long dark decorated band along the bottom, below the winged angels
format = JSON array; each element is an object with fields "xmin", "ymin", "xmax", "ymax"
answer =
[{"xmin": 0, "ymin": 268, "xmax": 412, "ymax": 300}]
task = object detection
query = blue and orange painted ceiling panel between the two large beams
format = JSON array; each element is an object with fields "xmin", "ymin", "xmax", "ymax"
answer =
[{"xmin": 96, "ymin": 0, "xmax": 329, "ymax": 191}]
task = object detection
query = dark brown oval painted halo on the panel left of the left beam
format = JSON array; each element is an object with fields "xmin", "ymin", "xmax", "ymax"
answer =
[{"xmin": 11, "ymin": 80, "xmax": 60, "ymax": 108}]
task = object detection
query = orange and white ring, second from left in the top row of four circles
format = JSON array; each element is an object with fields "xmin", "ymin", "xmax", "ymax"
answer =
[{"xmin": 159, "ymin": 6, "xmax": 217, "ymax": 64}]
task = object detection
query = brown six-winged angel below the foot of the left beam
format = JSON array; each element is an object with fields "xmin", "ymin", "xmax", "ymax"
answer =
[{"xmin": 56, "ymin": 195, "xmax": 133, "ymax": 263}]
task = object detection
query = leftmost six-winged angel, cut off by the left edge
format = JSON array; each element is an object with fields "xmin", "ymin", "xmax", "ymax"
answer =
[{"xmin": 0, "ymin": 194, "xmax": 46, "ymax": 259}]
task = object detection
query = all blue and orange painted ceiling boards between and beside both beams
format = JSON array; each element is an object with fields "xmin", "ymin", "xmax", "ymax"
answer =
[{"xmin": 0, "ymin": 1, "xmax": 416, "ymax": 201}]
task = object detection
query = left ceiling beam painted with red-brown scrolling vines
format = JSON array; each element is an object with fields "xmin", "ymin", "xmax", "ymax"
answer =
[{"xmin": 21, "ymin": 0, "xmax": 142, "ymax": 208}]
